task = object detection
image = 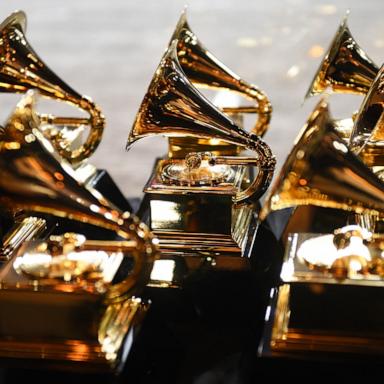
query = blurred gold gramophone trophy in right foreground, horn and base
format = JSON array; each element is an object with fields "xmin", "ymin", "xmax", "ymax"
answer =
[{"xmin": 259, "ymin": 100, "xmax": 384, "ymax": 361}]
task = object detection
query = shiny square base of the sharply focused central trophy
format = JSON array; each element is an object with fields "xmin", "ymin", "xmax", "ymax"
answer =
[{"xmin": 140, "ymin": 160, "xmax": 258, "ymax": 272}]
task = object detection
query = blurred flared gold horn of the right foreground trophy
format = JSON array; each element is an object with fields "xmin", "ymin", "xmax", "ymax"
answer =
[{"xmin": 260, "ymin": 100, "xmax": 384, "ymax": 220}]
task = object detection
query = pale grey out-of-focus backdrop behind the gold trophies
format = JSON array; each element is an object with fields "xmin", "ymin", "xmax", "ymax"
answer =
[{"xmin": 0, "ymin": 0, "xmax": 384, "ymax": 197}]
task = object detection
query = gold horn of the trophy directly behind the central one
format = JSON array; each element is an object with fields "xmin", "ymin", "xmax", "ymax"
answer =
[{"xmin": 170, "ymin": 11, "xmax": 272, "ymax": 136}]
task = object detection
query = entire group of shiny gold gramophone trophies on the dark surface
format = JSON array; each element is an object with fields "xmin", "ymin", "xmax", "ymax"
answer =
[{"xmin": 0, "ymin": 7, "xmax": 384, "ymax": 371}]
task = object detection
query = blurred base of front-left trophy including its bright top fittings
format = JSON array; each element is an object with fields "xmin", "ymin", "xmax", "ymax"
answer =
[{"xmin": 0, "ymin": 238, "xmax": 148, "ymax": 371}]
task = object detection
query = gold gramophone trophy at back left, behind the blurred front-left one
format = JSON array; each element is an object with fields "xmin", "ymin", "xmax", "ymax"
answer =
[{"xmin": 0, "ymin": 11, "xmax": 131, "ymax": 211}]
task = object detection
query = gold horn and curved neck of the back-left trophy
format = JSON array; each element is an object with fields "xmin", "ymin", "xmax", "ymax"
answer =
[{"xmin": 0, "ymin": 11, "xmax": 105, "ymax": 163}]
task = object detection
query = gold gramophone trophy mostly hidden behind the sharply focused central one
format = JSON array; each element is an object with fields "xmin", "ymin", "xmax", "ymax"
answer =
[{"xmin": 168, "ymin": 11, "xmax": 272, "ymax": 159}]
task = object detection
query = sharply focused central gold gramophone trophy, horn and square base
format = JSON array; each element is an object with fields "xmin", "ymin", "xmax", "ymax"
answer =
[{"xmin": 127, "ymin": 18, "xmax": 275, "ymax": 272}]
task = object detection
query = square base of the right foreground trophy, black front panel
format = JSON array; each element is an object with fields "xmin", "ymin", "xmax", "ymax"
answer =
[{"xmin": 259, "ymin": 233, "xmax": 384, "ymax": 362}]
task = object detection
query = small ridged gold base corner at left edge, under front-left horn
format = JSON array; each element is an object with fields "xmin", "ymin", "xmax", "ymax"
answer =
[{"xmin": 0, "ymin": 216, "xmax": 46, "ymax": 262}]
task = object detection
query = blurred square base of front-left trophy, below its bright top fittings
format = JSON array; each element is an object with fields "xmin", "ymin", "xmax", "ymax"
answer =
[{"xmin": 0, "ymin": 246, "xmax": 148, "ymax": 373}]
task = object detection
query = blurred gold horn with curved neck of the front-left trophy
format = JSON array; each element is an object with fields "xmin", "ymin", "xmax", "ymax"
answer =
[{"xmin": 0, "ymin": 91, "xmax": 157, "ymax": 296}]
